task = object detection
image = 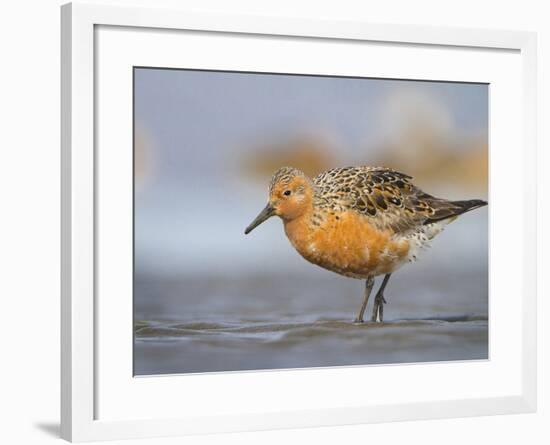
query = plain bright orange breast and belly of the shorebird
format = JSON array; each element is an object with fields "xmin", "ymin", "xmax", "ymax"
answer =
[{"xmin": 285, "ymin": 211, "xmax": 409, "ymax": 278}]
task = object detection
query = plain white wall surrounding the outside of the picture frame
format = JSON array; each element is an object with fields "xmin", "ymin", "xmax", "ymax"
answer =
[{"xmin": 0, "ymin": 0, "xmax": 550, "ymax": 444}]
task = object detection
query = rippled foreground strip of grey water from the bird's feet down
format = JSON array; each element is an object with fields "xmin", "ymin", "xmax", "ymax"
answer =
[{"xmin": 135, "ymin": 316, "xmax": 487, "ymax": 375}]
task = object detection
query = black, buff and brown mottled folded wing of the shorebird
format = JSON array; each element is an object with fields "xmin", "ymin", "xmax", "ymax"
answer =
[{"xmin": 314, "ymin": 167, "xmax": 470, "ymax": 232}]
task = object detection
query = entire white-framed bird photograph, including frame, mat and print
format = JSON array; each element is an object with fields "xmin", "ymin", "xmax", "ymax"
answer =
[{"xmin": 61, "ymin": 3, "xmax": 536, "ymax": 441}]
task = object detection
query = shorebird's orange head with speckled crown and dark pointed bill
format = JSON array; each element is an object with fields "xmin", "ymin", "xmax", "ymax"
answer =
[{"xmin": 244, "ymin": 167, "xmax": 313, "ymax": 234}]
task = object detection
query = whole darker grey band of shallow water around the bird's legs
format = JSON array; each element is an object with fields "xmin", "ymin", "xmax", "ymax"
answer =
[{"xmin": 134, "ymin": 256, "xmax": 488, "ymax": 375}]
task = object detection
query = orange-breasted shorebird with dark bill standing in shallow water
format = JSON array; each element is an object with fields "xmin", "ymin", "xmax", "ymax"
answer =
[{"xmin": 244, "ymin": 166, "xmax": 487, "ymax": 323}]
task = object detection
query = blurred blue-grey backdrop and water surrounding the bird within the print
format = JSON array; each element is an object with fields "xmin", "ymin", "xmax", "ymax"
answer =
[{"xmin": 134, "ymin": 68, "xmax": 488, "ymax": 375}]
